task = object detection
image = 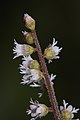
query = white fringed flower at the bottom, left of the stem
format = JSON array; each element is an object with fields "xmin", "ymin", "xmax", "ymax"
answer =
[{"xmin": 26, "ymin": 99, "xmax": 48, "ymax": 120}]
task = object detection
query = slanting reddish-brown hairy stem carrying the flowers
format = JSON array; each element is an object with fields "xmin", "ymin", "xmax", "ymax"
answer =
[{"xmin": 32, "ymin": 30, "xmax": 62, "ymax": 120}]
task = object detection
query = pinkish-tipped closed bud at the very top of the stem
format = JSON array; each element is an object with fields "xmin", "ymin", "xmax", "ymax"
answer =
[{"xmin": 24, "ymin": 14, "xmax": 35, "ymax": 30}]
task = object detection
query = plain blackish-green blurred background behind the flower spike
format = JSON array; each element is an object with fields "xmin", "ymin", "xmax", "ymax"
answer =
[{"xmin": 0, "ymin": 0, "xmax": 80, "ymax": 120}]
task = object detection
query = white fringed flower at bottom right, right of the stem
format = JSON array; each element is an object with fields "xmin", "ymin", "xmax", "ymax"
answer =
[{"xmin": 60, "ymin": 100, "xmax": 79, "ymax": 120}]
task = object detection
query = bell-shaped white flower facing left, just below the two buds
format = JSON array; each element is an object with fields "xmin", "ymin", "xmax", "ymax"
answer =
[{"xmin": 13, "ymin": 39, "xmax": 34, "ymax": 59}]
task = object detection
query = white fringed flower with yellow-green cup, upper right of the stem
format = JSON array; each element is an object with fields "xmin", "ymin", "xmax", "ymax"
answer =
[{"xmin": 44, "ymin": 38, "xmax": 62, "ymax": 63}]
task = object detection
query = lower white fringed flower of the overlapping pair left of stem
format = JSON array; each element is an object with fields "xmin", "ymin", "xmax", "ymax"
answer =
[{"xmin": 21, "ymin": 68, "xmax": 43, "ymax": 87}]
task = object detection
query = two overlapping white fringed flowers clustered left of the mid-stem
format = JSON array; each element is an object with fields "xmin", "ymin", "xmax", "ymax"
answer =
[{"xmin": 19, "ymin": 56, "xmax": 43, "ymax": 87}]
